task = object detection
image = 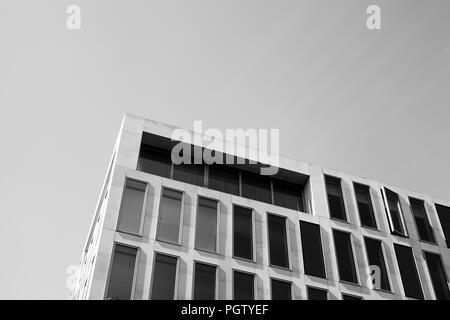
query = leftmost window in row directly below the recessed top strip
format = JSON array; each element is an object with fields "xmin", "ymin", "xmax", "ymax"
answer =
[{"xmin": 117, "ymin": 179, "xmax": 147, "ymax": 235}]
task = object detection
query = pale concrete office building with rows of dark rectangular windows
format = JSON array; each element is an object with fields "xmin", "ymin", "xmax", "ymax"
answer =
[{"xmin": 73, "ymin": 115, "xmax": 450, "ymax": 300}]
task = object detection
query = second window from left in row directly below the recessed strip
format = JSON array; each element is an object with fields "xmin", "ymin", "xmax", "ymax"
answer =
[{"xmin": 156, "ymin": 188, "xmax": 183, "ymax": 243}]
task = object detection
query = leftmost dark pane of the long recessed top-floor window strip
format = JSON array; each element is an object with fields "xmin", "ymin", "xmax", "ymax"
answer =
[{"xmin": 138, "ymin": 144, "xmax": 172, "ymax": 178}]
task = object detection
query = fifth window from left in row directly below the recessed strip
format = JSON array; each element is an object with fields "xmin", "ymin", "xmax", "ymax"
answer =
[{"xmin": 267, "ymin": 214, "xmax": 289, "ymax": 268}]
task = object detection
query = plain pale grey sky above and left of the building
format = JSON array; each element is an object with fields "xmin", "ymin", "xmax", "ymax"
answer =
[{"xmin": 0, "ymin": 0, "xmax": 450, "ymax": 299}]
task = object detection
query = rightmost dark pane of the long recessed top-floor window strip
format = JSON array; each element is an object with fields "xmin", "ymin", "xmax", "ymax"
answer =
[{"xmin": 273, "ymin": 180, "xmax": 304, "ymax": 211}]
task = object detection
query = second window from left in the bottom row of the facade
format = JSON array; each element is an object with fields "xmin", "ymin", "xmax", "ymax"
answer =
[{"xmin": 152, "ymin": 253, "xmax": 178, "ymax": 300}]
